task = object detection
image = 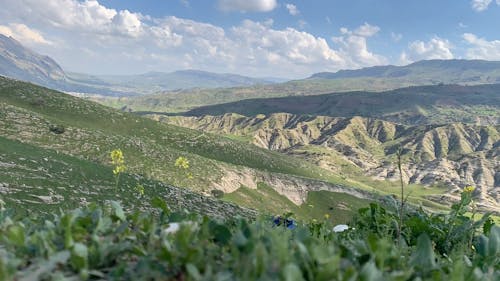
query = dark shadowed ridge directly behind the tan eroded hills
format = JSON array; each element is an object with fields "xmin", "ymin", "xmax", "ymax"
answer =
[{"xmin": 185, "ymin": 84, "xmax": 500, "ymax": 125}]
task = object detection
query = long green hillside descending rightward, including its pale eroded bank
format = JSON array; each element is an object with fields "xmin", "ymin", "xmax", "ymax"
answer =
[{"xmin": 0, "ymin": 78, "xmax": 402, "ymax": 219}]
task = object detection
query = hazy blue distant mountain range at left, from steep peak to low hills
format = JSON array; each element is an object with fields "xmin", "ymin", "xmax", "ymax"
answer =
[{"xmin": 0, "ymin": 34, "xmax": 282, "ymax": 96}]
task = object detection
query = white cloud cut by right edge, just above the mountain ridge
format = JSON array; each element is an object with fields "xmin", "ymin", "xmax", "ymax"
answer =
[{"xmin": 462, "ymin": 33, "xmax": 500, "ymax": 60}]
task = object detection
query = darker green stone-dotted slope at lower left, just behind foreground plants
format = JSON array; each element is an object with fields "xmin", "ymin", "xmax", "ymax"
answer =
[{"xmin": 0, "ymin": 137, "xmax": 253, "ymax": 216}]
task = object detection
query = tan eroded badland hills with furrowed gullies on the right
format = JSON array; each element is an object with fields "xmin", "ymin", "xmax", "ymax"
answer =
[{"xmin": 157, "ymin": 113, "xmax": 500, "ymax": 210}]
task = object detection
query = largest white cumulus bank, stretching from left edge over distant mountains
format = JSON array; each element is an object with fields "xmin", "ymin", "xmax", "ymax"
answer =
[{"xmin": 0, "ymin": 0, "xmax": 386, "ymax": 78}]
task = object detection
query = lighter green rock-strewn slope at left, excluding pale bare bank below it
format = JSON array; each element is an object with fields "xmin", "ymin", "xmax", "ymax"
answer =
[{"xmin": 0, "ymin": 76, "xmax": 376, "ymax": 219}]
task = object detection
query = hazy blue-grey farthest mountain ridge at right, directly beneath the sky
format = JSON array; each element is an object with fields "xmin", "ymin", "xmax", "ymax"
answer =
[{"xmin": 310, "ymin": 60, "xmax": 500, "ymax": 85}]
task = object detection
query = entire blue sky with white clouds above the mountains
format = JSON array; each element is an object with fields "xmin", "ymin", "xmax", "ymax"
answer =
[{"xmin": 0, "ymin": 0, "xmax": 500, "ymax": 78}]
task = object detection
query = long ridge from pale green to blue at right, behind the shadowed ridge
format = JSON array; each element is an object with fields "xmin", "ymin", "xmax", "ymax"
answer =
[{"xmin": 96, "ymin": 60, "xmax": 500, "ymax": 113}]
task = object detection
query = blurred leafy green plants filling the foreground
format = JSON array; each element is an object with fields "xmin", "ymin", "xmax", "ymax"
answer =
[{"xmin": 0, "ymin": 188, "xmax": 500, "ymax": 280}]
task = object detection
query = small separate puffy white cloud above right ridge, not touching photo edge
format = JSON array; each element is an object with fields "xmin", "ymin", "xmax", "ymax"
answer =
[{"xmin": 400, "ymin": 36, "xmax": 454, "ymax": 64}]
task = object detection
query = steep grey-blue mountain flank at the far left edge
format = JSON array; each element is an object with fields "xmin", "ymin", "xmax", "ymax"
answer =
[{"xmin": 0, "ymin": 34, "xmax": 67, "ymax": 88}]
